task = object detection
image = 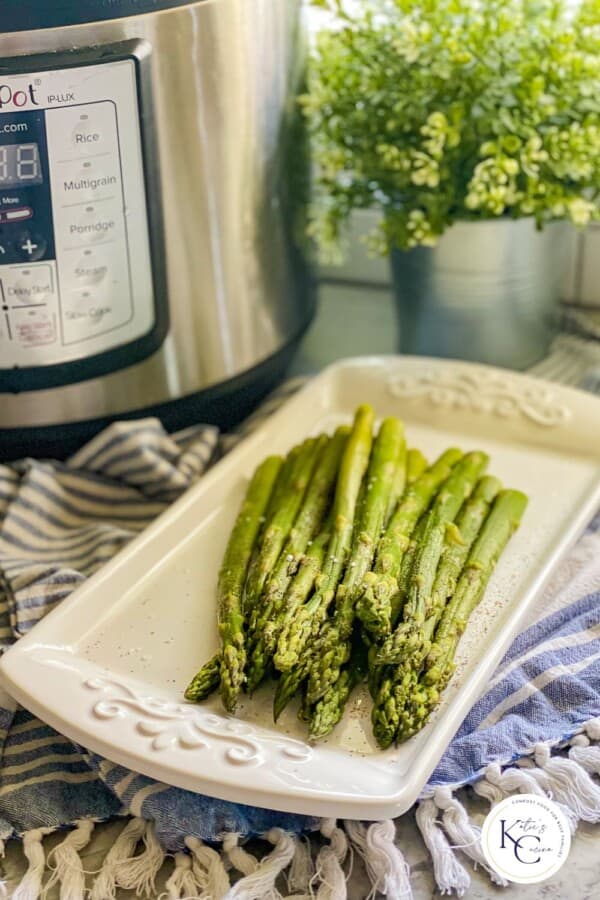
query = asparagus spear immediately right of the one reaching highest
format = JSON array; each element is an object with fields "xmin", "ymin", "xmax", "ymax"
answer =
[{"xmin": 307, "ymin": 418, "xmax": 404, "ymax": 703}]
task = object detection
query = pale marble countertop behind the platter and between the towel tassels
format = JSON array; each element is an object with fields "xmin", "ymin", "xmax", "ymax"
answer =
[{"xmin": 3, "ymin": 283, "xmax": 600, "ymax": 900}]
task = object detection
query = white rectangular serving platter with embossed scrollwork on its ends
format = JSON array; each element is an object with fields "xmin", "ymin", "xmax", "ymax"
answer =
[{"xmin": 0, "ymin": 357, "xmax": 600, "ymax": 819}]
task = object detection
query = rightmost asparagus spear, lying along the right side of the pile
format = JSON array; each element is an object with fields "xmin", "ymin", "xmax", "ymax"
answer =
[{"xmin": 396, "ymin": 491, "xmax": 527, "ymax": 741}]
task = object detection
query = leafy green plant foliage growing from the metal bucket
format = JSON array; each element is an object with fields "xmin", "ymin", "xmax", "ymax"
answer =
[{"xmin": 303, "ymin": 0, "xmax": 600, "ymax": 253}]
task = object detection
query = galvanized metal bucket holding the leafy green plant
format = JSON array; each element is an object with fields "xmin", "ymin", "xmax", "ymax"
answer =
[{"xmin": 392, "ymin": 219, "xmax": 572, "ymax": 369}]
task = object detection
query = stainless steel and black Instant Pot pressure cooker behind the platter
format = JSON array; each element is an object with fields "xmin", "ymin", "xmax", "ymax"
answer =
[{"xmin": 0, "ymin": 0, "xmax": 314, "ymax": 459}]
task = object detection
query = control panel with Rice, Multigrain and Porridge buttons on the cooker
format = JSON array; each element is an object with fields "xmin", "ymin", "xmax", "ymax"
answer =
[{"xmin": 0, "ymin": 48, "xmax": 162, "ymax": 391}]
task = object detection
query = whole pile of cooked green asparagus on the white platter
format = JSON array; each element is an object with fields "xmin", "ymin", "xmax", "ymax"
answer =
[{"xmin": 185, "ymin": 405, "xmax": 526, "ymax": 747}]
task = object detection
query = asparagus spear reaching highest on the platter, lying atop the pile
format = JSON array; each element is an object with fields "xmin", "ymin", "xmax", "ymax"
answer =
[{"xmin": 274, "ymin": 405, "xmax": 374, "ymax": 672}]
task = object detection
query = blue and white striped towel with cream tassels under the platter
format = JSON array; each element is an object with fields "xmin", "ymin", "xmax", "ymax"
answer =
[{"xmin": 0, "ymin": 394, "xmax": 600, "ymax": 900}]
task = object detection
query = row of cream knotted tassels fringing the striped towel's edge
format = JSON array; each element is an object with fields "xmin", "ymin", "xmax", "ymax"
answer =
[{"xmin": 9, "ymin": 719, "xmax": 600, "ymax": 900}]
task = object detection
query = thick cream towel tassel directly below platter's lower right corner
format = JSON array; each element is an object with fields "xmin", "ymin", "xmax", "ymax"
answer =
[{"xmin": 344, "ymin": 819, "xmax": 412, "ymax": 900}]
